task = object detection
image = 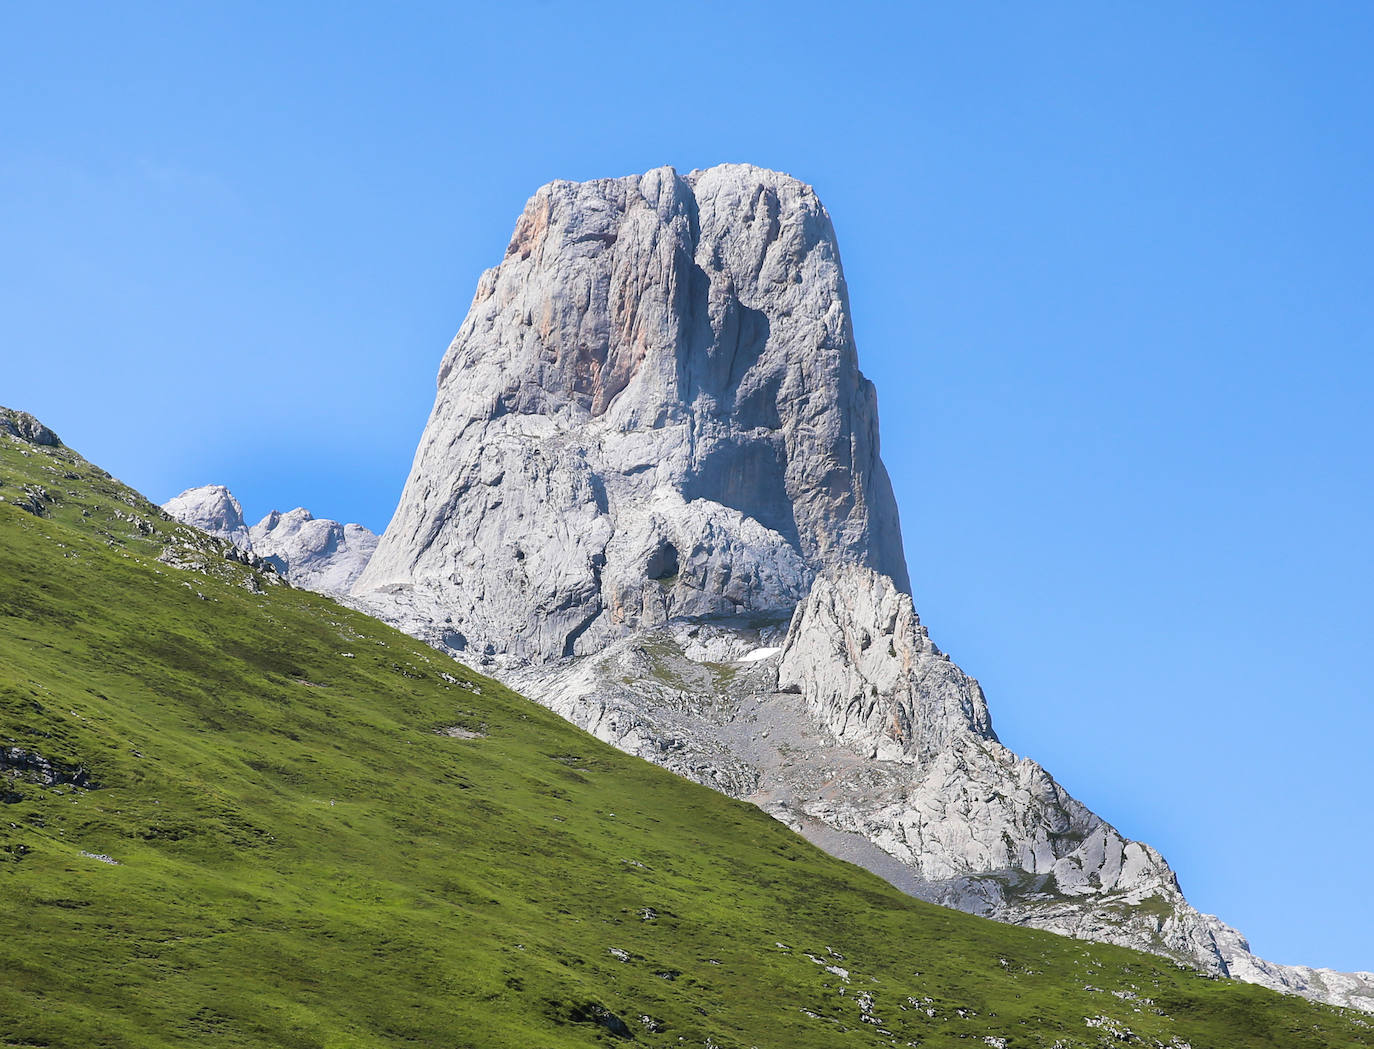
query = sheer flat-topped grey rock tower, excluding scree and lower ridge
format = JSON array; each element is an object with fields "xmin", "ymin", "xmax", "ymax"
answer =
[{"xmin": 353, "ymin": 165, "xmax": 907, "ymax": 660}]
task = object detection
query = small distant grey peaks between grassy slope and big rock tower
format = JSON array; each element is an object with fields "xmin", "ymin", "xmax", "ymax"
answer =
[{"xmin": 162, "ymin": 484, "xmax": 376, "ymax": 597}]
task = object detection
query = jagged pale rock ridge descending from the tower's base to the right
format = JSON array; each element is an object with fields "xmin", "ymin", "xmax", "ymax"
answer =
[{"xmin": 778, "ymin": 566, "xmax": 1374, "ymax": 1009}]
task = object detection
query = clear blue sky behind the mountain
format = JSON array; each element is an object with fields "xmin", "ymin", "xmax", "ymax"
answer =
[{"xmin": 0, "ymin": 0, "xmax": 1374, "ymax": 969}]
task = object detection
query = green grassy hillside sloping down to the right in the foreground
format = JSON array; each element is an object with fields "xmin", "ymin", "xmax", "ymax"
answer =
[{"xmin": 0, "ymin": 412, "xmax": 1374, "ymax": 1049}]
